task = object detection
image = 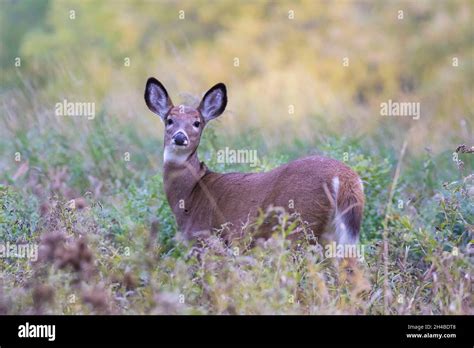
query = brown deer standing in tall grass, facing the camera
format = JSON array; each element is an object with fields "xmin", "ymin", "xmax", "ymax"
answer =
[{"xmin": 145, "ymin": 77, "xmax": 366, "ymax": 288}]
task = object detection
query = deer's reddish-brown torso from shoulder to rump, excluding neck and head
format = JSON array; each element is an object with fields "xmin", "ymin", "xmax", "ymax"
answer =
[{"xmin": 191, "ymin": 156, "xmax": 361, "ymax": 241}]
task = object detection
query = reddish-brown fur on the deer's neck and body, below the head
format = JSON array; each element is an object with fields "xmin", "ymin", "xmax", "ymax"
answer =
[{"xmin": 164, "ymin": 152, "xmax": 364, "ymax": 245}]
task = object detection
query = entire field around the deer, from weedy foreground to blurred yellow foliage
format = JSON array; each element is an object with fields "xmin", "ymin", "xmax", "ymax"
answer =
[{"xmin": 0, "ymin": 0, "xmax": 474, "ymax": 315}]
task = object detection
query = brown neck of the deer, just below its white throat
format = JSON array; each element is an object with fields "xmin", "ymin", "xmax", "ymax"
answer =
[{"xmin": 163, "ymin": 151, "xmax": 207, "ymax": 216}]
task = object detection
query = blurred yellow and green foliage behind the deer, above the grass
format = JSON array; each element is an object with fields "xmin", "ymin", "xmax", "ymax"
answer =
[{"xmin": 0, "ymin": 0, "xmax": 474, "ymax": 156}]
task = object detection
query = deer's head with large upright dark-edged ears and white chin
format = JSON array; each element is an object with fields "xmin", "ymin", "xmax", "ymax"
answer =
[{"xmin": 145, "ymin": 77, "xmax": 227, "ymax": 163}]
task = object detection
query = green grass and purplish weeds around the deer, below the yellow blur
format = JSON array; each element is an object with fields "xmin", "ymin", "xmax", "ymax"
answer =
[{"xmin": 0, "ymin": 104, "xmax": 474, "ymax": 314}]
